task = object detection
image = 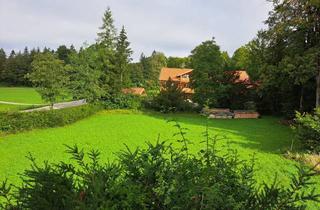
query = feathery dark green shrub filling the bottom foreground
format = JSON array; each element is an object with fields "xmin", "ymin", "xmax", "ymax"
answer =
[{"xmin": 0, "ymin": 125, "xmax": 319, "ymax": 210}]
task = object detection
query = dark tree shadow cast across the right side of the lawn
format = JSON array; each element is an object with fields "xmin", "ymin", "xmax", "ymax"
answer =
[{"xmin": 143, "ymin": 111, "xmax": 299, "ymax": 154}]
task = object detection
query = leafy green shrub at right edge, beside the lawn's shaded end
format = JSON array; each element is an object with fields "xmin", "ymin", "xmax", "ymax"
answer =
[{"xmin": 293, "ymin": 108, "xmax": 320, "ymax": 153}]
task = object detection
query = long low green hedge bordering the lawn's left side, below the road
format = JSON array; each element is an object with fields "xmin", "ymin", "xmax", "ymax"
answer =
[{"xmin": 0, "ymin": 105, "xmax": 102, "ymax": 132}]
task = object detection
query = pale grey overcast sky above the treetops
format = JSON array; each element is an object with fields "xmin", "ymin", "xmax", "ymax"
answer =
[{"xmin": 0, "ymin": 0, "xmax": 271, "ymax": 59}]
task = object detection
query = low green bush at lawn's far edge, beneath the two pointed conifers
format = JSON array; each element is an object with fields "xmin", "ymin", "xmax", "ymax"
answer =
[{"xmin": 103, "ymin": 93, "xmax": 142, "ymax": 109}]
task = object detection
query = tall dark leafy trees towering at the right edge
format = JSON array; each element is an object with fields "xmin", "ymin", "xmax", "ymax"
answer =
[{"xmin": 248, "ymin": 0, "xmax": 320, "ymax": 116}]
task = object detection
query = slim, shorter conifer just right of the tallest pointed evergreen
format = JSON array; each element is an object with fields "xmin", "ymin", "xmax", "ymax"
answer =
[{"xmin": 115, "ymin": 26, "xmax": 132, "ymax": 88}]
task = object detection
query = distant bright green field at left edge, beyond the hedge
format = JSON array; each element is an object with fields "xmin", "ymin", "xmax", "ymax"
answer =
[{"xmin": 0, "ymin": 87, "xmax": 44, "ymax": 104}]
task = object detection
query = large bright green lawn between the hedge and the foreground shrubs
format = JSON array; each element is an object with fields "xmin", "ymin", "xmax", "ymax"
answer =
[{"xmin": 0, "ymin": 111, "xmax": 320, "ymax": 208}]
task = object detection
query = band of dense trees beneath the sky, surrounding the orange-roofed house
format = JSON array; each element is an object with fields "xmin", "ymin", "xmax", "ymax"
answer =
[{"xmin": 0, "ymin": 0, "xmax": 320, "ymax": 117}]
